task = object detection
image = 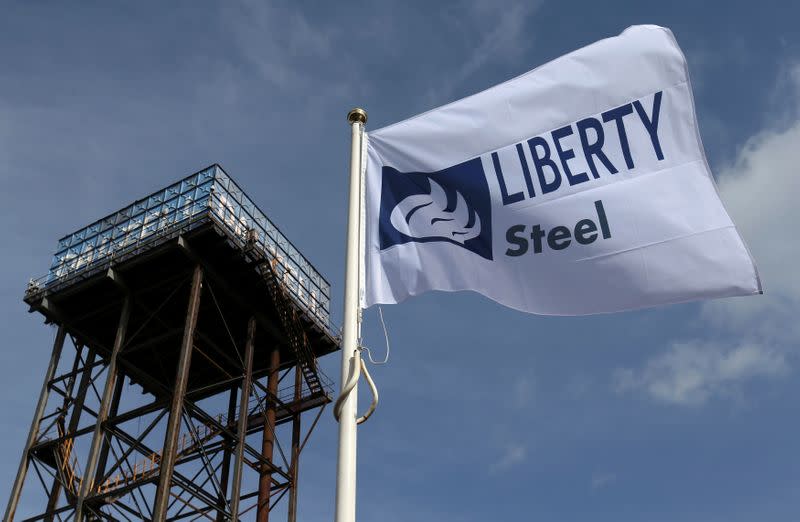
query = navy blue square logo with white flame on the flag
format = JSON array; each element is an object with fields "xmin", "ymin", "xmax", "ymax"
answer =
[{"xmin": 379, "ymin": 158, "xmax": 492, "ymax": 259}]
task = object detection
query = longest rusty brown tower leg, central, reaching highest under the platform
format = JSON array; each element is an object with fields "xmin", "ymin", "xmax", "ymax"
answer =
[{"xmin": 153, "ymin": 265, "xmax": 203, "ymax": 522}]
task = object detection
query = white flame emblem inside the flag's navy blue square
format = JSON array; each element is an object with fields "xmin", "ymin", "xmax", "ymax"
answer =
[{"xmin": 389, "ymin": 179, "xmax": 481, "ymax": 245}]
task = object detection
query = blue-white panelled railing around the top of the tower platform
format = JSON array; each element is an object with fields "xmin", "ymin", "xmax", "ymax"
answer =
[{"xmin": 25, "ymin": 165, "xmax": 333, "ymax": 331}]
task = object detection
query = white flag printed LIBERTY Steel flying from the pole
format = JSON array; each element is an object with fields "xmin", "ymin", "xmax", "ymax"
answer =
[{"xmin": 362, "ymin": 26, "xmax": 761, "ymax": 315}]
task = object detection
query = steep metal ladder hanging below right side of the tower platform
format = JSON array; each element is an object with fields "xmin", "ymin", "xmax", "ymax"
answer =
[{"xmin": 262, "ymin": 258, "xmax": 324, "ymax": 395}]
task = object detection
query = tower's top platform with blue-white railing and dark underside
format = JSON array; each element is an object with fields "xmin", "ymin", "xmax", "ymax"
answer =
[{"xmin": 25, "ymin": 165, "xmax": 338, "ymax": 397}]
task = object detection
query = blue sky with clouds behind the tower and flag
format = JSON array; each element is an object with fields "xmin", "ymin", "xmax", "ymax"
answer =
[{"xmin": 0, "ymin": 0, "xmax": 800, "ymax": 522}]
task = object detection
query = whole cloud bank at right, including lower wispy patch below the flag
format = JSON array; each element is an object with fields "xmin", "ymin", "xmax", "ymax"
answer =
[{"xmin": 614, "ymin": 65, "xmax": 800, "ymax": 406}]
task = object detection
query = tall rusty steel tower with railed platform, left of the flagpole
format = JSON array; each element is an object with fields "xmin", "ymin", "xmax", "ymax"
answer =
[{"xmin": 3, "ymin": 165, "xmax": 339, "ymax": 522}]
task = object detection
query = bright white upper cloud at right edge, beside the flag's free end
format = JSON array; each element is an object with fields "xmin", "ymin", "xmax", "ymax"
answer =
[{"xmin": 703, "ymin": 66, "xmax": 800, "ymax": 344}]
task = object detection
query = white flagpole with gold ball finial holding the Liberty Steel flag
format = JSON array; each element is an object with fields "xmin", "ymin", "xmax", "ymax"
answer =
[{"xmin": 335, "ymin": 109, "xmax": 367, "ymax": 522}]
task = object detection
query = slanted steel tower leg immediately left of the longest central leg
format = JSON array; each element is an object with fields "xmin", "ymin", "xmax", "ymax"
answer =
[{"xmin": 75, "ymin": 295, "xmax": 131, "ymax": 522}]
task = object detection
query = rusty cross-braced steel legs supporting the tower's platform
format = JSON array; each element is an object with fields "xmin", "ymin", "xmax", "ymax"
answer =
[{"xmin": 4, "ymin": 250, "xmax": 330, "ymax": 522}]
